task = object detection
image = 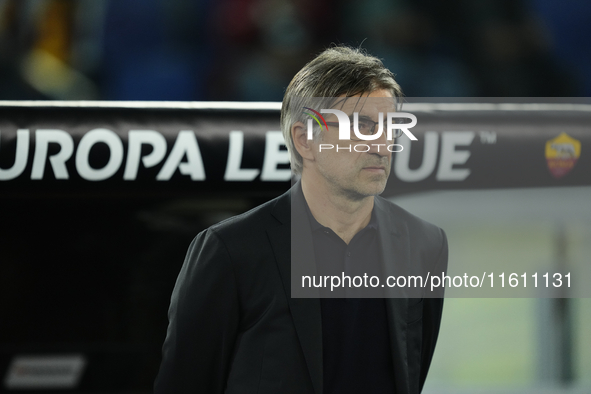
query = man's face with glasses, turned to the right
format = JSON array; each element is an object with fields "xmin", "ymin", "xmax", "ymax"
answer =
[{"xmin": 311, "ymin": 90, "xmax": 395, "ymax": 200}]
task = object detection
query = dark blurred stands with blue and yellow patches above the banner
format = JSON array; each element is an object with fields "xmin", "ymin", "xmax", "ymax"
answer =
[{"xmin": 0, "ymin": 0, "xmax": 591, "ymax": 101}]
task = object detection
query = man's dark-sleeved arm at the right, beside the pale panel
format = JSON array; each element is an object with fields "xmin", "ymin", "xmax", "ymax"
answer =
[{"xmin": 419, "ymin": 230, "xmax": 448, "ymax": 392}]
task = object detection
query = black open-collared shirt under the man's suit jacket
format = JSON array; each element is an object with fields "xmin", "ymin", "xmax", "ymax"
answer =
[{"xmin": 306, "ymin": 189, "xmax": 395, "ymax": 394}]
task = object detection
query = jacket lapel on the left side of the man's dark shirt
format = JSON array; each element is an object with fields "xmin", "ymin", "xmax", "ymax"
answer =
[{"xmin": 267, "ymin": 184, "xmax": 323, "ymax": 394}]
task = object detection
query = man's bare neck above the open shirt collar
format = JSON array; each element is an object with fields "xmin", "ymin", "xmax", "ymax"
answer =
[{"xmin": 301, "ymin": 176, "xmax": 374, "ymax": 244}]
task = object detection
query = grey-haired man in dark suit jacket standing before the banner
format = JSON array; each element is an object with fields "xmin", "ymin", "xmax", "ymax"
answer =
[{"xmin": 155, "ymin": 47, "xmax": 447, "ymax": 394}]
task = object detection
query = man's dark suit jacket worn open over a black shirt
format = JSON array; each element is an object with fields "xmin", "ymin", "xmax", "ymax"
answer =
[{"xmin": 154, "ymin": 185, "xmax": 447, "ymax": 394}]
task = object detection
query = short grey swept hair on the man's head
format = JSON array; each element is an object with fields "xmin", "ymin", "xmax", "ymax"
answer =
[{"xmin": 281, "ymin": 46, "xmax": 403, "ymax": 174}]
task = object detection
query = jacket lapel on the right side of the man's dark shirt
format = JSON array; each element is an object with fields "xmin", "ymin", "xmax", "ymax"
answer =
[{"xmin": 374, "ymin": 197, "xmax": 410, "ymax": 394}]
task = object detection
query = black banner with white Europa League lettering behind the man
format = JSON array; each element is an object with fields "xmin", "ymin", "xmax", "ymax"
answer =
[{"xmin": 0, "ymin": 98, "xmax": 591, "ymax": 197}]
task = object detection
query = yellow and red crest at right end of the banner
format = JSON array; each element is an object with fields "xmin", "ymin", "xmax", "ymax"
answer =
[{"xmin": 546, "ymin": 133, "xmax": 581, "ymax": 178}]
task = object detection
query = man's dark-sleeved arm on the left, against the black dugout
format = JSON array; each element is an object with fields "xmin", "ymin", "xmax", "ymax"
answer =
[{"xmin": 154, "ymin": 229, "xmax": 239, "ymax": 394}]
